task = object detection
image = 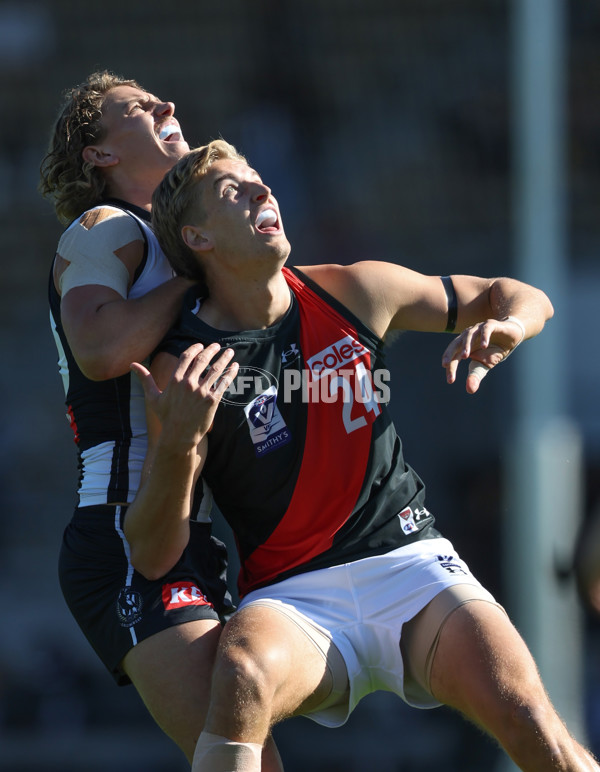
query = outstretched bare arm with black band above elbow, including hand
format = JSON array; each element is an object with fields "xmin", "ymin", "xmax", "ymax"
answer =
[{"xmin": 303, "ymin": 261, "xmax": 554, "ymax": 394}]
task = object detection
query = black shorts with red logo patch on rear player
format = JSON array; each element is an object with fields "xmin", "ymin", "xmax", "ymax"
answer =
[{"xmin": 58, "ymin": 505, "xmax": 234, "ymax": 685}]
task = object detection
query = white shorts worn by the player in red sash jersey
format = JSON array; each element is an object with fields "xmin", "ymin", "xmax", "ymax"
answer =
[{"xmin": 240, "ymin": 538, "xmax": 498, "ymax": 727}]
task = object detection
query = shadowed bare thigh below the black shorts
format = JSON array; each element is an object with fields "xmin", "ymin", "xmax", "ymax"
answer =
[{"xmin": 123, "ymin": 619, "xmax": 222, "ymax": 759}]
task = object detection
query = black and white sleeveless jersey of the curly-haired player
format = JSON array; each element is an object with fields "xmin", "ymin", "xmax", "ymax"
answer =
[{"xmin": 49, "ymin": 199, "xmax": 173, "ymax": 506}]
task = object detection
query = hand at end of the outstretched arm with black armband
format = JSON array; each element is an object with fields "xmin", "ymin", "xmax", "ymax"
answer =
[{"xmin": 442, "ymin": 319, "xmax": 525, "ymax": 394}]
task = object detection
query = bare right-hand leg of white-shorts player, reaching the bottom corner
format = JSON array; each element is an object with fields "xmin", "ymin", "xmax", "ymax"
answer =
[{"xmin": 431, "ymin": 601, "xmax": 600, "ymax": 772}]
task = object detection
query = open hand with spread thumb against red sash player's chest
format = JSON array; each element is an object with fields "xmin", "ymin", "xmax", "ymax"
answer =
[{"xmin": 131, "ymin": 343, "xmax": 239, "ymax": 446}]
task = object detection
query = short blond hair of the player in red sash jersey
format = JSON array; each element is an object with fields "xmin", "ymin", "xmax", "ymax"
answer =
[{"xmin": 152, "ymin": 139, "xmax": 247, "ymax": 281}]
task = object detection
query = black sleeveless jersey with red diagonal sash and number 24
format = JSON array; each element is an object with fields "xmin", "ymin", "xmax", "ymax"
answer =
[{"xmin": 161, "ymin": 268, "xmax": 439, "ymax": 597}]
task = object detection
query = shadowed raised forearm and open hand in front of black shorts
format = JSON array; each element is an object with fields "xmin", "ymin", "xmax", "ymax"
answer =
[{"xmin": 124, "ymin": 343, "xmax": 238, "ymax": 579}]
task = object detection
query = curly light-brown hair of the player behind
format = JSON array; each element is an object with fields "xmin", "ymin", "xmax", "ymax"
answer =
[{"xmin": 38, "ymin": 70, "xmax": 145, "ymax": 225}]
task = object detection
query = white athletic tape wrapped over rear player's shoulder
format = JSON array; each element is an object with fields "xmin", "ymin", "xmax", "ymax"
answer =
[{"xmin": 58, "ymin": 209, "xmax": 142, "ymax": 298}]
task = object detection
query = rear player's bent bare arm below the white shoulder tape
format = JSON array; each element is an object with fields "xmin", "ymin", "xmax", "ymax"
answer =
[{"xmin": 70, "ymin": 277, "xmax": 190, "ymax": 380}]
